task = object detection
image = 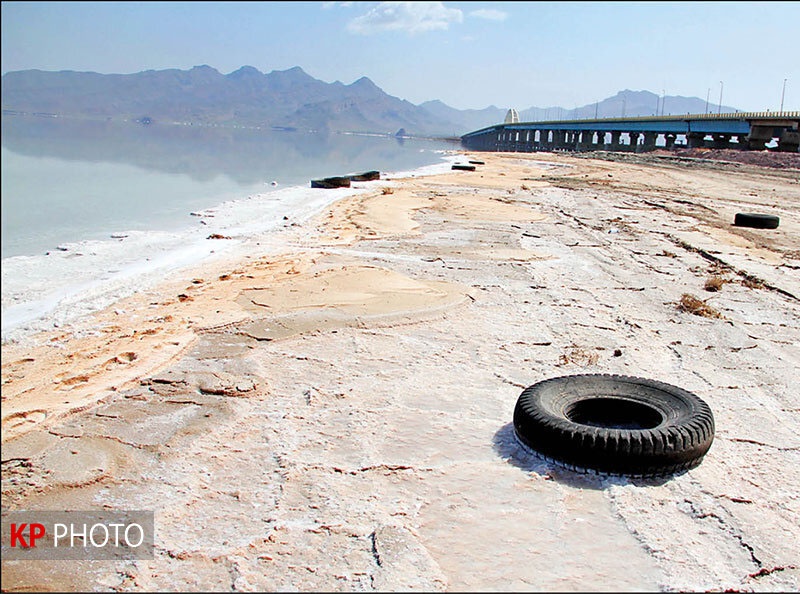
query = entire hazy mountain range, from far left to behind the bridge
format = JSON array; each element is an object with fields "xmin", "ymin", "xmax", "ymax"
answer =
[{"xmin": 2, "ymin": 65, "xmax": 735, "ymax": 136}]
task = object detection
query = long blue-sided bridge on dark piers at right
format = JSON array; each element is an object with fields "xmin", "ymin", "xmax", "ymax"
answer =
[{"xmin": 461, "ymin": 111, "xmax": 800, "ymax": 152}]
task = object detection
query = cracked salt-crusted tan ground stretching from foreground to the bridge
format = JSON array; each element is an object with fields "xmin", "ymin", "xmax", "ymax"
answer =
[{"xmin": 2, "ymin": 154, "xmax": 800, "ymax": 591}]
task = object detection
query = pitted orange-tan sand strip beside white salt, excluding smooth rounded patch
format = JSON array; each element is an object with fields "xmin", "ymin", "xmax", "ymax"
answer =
[{"xmin": 2, "ymin": 258, "xmax": 311, "ymax": 441}]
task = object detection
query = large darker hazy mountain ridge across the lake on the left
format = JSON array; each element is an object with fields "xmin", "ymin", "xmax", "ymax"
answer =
[{"xmin": 2, "ymin": 66, "xmax": 454, "ymax": 134}]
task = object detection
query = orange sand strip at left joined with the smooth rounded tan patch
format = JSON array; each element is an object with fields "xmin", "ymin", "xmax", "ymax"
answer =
[{"xmin": 2, "ymin": 250, "xmax": 466, "ymax": 441}]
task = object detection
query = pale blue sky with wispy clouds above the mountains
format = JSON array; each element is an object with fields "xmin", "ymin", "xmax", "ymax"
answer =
[{"xmin": 0, "ymin": 1, "xmax": 800, "ymax": 111}]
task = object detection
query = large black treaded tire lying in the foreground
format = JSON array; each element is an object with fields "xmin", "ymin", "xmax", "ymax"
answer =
[{"xmin": 514, "ymin": 374, "xmax": 714, "ymax": 476}]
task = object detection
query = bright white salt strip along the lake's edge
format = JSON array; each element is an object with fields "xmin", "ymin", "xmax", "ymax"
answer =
[{"xmin": 2, "ymin": 151, "xmax": 460, "ymax": 343}]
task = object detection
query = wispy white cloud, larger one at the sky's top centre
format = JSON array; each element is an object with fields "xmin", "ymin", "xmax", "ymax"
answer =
[{"xmin": 347, "ymin": 2, "xmax": 464, "ymax": 35}]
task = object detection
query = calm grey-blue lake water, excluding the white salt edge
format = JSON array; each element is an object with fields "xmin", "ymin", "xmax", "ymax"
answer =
[{"xmin": 2, "ymin": 116, "xmax": 454, "ymax": 258}]
